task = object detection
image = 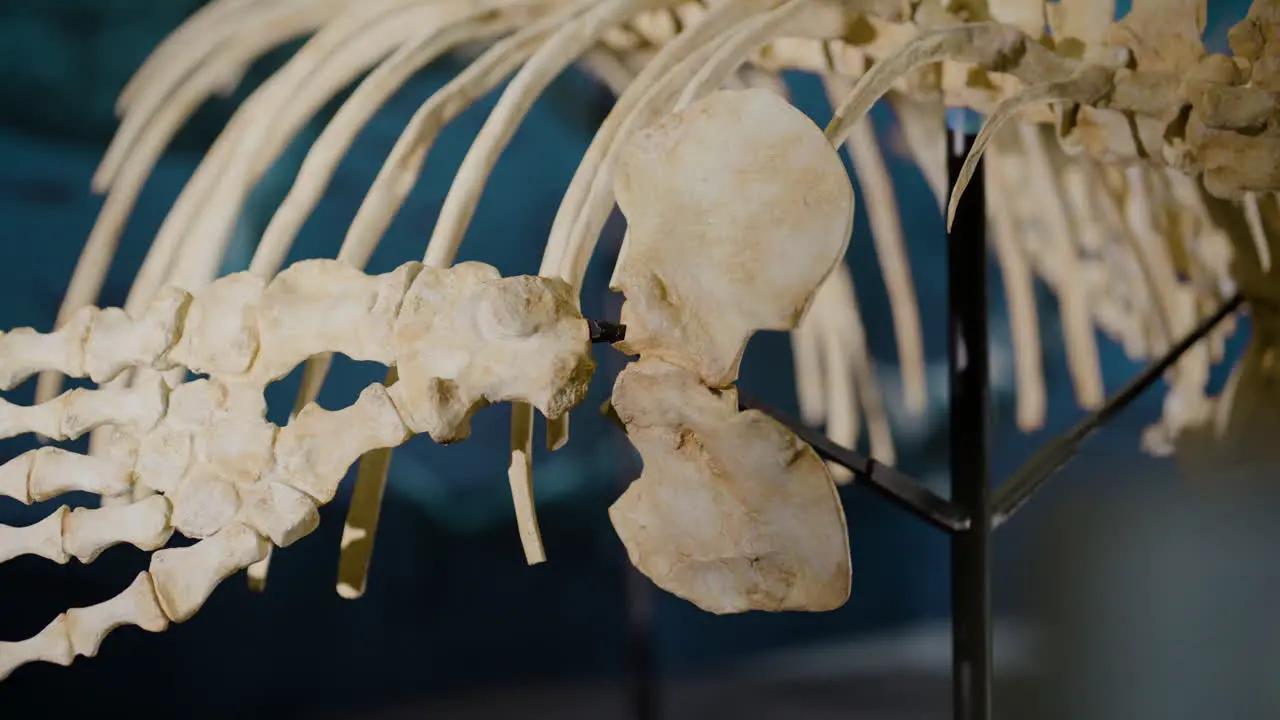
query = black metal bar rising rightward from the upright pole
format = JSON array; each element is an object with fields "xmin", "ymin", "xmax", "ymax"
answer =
[{"xmin": 991, "ymin": 295, "xmax": 1243, "ymax": 527}]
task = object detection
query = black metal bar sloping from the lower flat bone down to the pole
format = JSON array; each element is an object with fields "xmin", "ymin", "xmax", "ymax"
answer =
[{"xmin": 737, "ymin": 389, "xmax": 969, "ymax": 533}]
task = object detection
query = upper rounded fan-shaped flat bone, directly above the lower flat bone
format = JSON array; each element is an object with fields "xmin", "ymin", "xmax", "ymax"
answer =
[{"xmin": 617, "ymin": 90, "xmax": 854, "ymax": 387}]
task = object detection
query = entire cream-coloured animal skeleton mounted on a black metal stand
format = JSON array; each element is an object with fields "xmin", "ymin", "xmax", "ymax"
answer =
[{"xmin": 0, "ymin": 0, "xmax": 1280, "ymax": 674}]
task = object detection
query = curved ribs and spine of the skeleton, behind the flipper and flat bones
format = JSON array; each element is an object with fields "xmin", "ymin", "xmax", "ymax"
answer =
[{"xmin": 2, "ymin": 0, "xmax": 1280, "ymax": 671}]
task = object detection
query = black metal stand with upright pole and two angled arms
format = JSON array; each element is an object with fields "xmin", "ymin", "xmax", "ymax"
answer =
[{"xmin": 590, "ymin": 131, "xmax": 1243, "ymax": 720}]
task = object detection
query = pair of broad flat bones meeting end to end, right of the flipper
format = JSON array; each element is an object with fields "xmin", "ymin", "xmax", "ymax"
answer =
[{"xmin": 609, "ymin": 90, "xmax": 854, "ymax": 612}]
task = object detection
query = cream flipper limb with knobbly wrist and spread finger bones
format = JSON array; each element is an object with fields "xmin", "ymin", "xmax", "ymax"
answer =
[{"xmin": 0, "ymin": 260, "xmax": 594, "ymax": 678}]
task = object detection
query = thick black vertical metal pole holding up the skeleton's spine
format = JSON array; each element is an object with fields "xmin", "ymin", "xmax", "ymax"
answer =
[{"xmin": 947, "ymin": 123, "xmax": 992, "ymax": 720}]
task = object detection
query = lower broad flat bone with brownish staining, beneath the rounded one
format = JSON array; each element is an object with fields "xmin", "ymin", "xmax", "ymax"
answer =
[{"xmin": 609, "ymin": 359, "xmax": 850, "ymax": 614}]
